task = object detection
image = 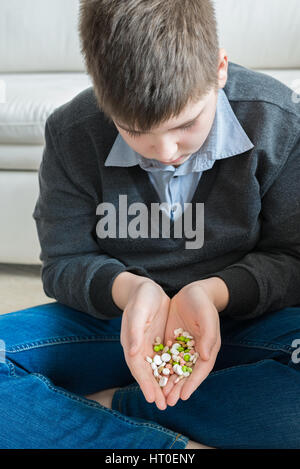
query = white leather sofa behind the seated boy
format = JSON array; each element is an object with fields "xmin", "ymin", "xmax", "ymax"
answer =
[{"xmin": 0, "ymin": 0, "xmax": 300, "ymax": 264}]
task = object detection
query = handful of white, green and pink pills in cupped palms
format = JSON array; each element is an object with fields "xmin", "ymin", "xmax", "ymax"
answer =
[{"xmin": 146, "ymin": 327, "xmax": 199, "ymax": 387}]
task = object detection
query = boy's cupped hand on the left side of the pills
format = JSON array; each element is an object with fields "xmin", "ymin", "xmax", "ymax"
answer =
[{"xmin": 120, "ymin": 277, "xmax": 170, "ymax": 410}]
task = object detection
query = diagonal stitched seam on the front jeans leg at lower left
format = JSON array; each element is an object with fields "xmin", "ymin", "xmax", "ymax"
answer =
[{"xmin": 31, "ymin": 373, "xmax": 187, "ymax": 444}]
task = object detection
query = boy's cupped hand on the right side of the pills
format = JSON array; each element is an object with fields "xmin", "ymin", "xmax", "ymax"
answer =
[{"xmin": 163, "ymin": 282, "xmax": 221, "ymax": 406}]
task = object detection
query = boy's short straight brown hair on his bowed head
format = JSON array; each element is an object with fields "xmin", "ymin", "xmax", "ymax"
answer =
[{"xmin": 79, "ymin": 0, "xmax": 219, "ymax": 131}]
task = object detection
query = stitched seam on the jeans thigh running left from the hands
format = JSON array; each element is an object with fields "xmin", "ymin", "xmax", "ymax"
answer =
[{"xmin": 6, "ymin": 336, "xmax": 120, "ymax": 353}]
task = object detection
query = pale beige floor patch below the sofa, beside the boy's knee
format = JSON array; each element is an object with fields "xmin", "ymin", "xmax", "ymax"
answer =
[{"xmin": 0, "ymin": 264, "xmax": 55, "ymax": 314}]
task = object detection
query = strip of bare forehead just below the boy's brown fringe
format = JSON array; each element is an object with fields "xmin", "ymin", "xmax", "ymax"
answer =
[{"xmin": 115, "ymin": 88, "xmax": 213, "ymax": 133}]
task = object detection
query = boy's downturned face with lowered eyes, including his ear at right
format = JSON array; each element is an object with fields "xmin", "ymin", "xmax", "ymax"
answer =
[{"xmin": 114, "ymin": 49, "xmax": 228, "ymax": 167}]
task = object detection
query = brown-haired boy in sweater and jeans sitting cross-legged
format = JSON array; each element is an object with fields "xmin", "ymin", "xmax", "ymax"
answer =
[{"xmin": 0, "ymin": 0, "xmax": 300, "ymax": 449}]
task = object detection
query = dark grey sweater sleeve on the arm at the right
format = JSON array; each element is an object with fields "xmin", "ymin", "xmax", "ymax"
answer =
[{"xmin": 205, "ymin": 135, "xmax": 300, "ymax": 320}]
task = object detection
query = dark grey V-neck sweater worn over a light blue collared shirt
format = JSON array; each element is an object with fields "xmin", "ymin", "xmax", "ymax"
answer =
[{"xmin": 33, "ymin": 63, "xmax": 300, "ymax": 320}]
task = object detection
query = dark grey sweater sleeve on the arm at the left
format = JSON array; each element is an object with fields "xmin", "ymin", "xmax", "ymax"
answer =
[{"xmin": 33, "ymin": 116, "xmax": 149, "ymax": 319}]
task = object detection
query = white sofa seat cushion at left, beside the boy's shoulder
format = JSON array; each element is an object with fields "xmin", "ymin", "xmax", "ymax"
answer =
[{"xmin": 0, "ymin": 72, "xmax": 92, "ymax": 144}]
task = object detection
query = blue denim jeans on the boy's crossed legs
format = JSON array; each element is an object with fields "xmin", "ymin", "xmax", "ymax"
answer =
[{"xmin": 0, "ymin": 303, "xmax": 300, "ymax": 449}]
